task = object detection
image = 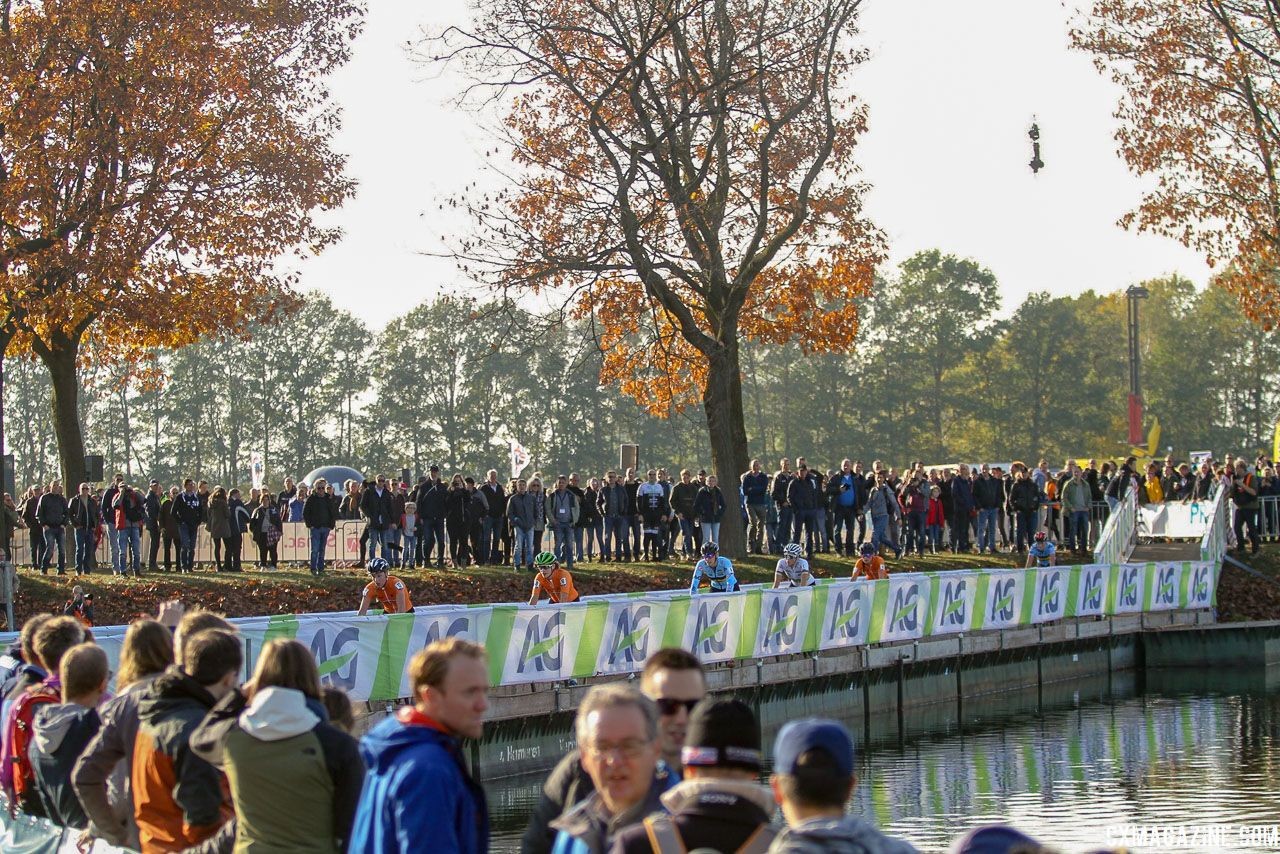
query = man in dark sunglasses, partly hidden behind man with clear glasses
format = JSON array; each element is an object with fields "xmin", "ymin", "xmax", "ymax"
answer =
[{"xmin": 521, "ymin": 648, "xmax": 707, "ymax": 854}]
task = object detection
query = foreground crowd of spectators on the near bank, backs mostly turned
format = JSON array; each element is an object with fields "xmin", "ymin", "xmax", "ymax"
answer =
[{"xmin": 0, "ymin": 614, "xmax": 1100, "ymax": 854}]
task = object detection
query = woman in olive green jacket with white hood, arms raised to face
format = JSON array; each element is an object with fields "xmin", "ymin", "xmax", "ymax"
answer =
[{"xmin": 191, "ymin": 640, "xmax": 365, "ymax": 854}]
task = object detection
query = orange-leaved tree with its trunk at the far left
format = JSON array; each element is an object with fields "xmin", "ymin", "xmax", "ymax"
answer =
[{"xmin": 0, "ymin": 0, "xmax": 362, "ymax": 484}]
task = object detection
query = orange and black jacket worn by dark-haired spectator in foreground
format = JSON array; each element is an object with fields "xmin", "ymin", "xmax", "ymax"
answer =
[{"xmin": 133, "ymin": 667, "xmax": 233, "ymax": 854}]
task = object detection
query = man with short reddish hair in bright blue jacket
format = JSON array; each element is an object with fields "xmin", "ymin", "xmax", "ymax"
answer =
[{"xmin": 348, "ymin": 638, "xmax": 489, "ymax": 854}]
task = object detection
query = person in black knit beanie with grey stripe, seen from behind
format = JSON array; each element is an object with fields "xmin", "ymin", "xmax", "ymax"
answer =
[{"xmin": 611, "ymin": 699, "xmax": 776, "ymax": 854}]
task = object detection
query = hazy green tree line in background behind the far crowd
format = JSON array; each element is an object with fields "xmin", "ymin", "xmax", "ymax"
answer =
[{"xmin": 4, "ymin": 251, "xmax": 1280, "ymax": 487}]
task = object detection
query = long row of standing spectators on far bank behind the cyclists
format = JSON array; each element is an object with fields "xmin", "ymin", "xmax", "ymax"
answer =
[{"xmin": 0, "ymin": 455, "xmax": 1280, "ymax": 575}]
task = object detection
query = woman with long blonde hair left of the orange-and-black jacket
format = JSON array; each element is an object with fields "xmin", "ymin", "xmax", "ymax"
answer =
[{"xmin": 72, "ymin": 620, "xmax": 173, "ymax": 850}]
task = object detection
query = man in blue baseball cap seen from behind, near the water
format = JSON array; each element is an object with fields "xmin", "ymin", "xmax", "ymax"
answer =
[{"xmin": 769, "ymin": 718, "xmax": 915, "ymax": 854}]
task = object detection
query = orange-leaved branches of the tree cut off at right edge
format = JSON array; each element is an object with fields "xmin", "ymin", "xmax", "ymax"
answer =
[{"xmin": 1071, "ymin": 0, "xmax": 1280, "ymax": 329}]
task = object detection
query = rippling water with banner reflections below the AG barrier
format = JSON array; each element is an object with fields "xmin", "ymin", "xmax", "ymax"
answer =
[{"xmin": 486, "ymin": 668, "xmax": 1280, "ymax": 851}]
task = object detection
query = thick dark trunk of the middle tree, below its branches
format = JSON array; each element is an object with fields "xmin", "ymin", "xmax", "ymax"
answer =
[{"xmin": 703, "ymin": 341, "xmax": 748, "ymax": 558}]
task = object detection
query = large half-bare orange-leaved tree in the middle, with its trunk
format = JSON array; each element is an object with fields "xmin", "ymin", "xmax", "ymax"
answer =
[{"xmin": 424, "ymin": 0, "xmax": 884, "ymax": 553}]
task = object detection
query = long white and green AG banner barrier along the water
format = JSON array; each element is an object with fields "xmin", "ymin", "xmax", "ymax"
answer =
[{"xmin": 20, "ymin": 561, "xmax": 1220, "ymax": 700}]
